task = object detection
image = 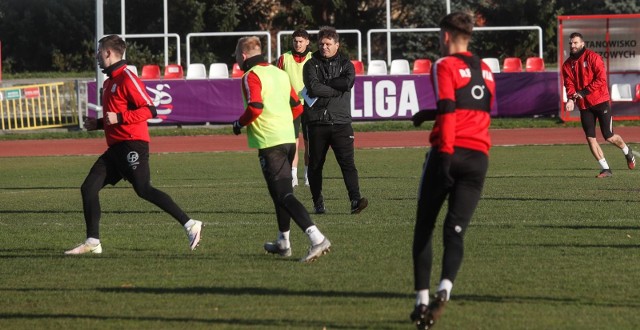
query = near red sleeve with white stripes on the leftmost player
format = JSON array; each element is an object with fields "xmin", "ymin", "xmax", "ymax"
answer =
[{"xmin": 118, "ymin": 75, "xmax": 158, "ymax": 125}]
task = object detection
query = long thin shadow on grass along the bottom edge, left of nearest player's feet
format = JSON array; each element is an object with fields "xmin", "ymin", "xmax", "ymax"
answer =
[{"xmin": 0, "ymin": 311, "xmax": 396, "ymax": 329}]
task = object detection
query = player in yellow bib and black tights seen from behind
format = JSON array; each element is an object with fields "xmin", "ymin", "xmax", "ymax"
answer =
[{"xmin": 233, "ymin": 36, "xmax": 331, "ymax": 262}]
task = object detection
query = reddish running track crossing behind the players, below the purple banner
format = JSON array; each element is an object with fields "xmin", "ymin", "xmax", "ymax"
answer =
[{"xmin": 0, "ymin": 127, "xmax": 640, "ymax": 157}]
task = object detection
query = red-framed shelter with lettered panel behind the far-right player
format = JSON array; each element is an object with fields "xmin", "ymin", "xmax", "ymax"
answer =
[{"xmin": 558, "ymin": 14, "xmax": 640, "ymax": 121}]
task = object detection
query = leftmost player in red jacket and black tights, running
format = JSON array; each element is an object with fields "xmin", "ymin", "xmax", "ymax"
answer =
[{"xmin": 65, "ymin": 35, "xmax": 202, "ymax": 254}]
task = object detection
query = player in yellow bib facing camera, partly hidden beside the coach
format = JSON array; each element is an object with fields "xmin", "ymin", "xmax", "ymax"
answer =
[{"xmin": 277, "ymin": 29, "xmax": 311, "ymax": 187}]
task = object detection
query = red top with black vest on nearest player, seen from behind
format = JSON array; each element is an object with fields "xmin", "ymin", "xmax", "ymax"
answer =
[{"xmin": 429, "ymin": 52, "xmax": 496, "ymax": 154}]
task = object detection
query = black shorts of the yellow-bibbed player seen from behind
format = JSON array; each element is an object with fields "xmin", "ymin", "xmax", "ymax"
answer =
[{"xmin": 258, "ymin": 143, "xmax": 296, "ymax": 182}]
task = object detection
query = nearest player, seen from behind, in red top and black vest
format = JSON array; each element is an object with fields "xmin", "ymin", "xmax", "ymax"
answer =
[{"xmin": 411, "ymin": 12, "xmax": 495, "ymax": 329}]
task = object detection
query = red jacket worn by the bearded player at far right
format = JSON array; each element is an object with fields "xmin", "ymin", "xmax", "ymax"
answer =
[{"xmin": 562, "ymin": 49, "xmax": 610, "ymax": 110}]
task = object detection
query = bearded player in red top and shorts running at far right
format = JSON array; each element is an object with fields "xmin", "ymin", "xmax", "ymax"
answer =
[{"xmin": 562, "ymin": 32, "xmax": 636, "ymax": 178}]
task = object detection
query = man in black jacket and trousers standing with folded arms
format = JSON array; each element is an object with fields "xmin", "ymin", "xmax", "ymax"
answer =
[{"xmin": 302, "ymin": 26, "xmax": 368, "ymax": 214}]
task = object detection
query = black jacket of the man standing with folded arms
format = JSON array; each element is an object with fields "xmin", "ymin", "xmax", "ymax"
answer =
[{"xmin": 302, "ymin": 51, "xmax": 356, "ymax": 125}]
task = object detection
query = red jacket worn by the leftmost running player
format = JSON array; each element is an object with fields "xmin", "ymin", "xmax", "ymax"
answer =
[{"xmin": 102, "ymin": 61, "xmax": 156, "ymax": 146}]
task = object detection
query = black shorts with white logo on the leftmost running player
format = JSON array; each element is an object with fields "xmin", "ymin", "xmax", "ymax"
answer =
[{"xmin": 91, "ymin": 141, "xmax": 150, "ymax": 185}]
